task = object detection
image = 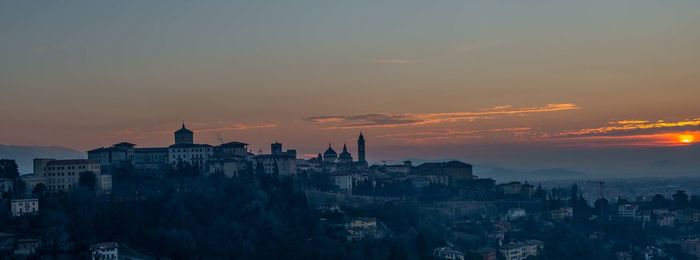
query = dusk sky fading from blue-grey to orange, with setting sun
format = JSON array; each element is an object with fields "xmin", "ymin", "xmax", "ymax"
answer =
[{"xmin": 0, "ymin": 0, "xmax": 700, "ymax": 176}]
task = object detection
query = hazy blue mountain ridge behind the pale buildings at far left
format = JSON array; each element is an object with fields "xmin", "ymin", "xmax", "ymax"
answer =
[{"xmin": 0, "ymin": 144, "xmax": 87, "ymax": 174}]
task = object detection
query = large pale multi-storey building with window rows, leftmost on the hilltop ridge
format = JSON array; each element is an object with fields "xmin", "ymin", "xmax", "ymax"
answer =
[{"xmin": 30, "ymin": 159, "xmax": 112, "ymax": 193}]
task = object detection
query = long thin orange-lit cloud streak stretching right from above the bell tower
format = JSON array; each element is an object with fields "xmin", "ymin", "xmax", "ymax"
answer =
[{"xmin": 305, "ymin": 103, "xmax": 581, "ymax": 129}]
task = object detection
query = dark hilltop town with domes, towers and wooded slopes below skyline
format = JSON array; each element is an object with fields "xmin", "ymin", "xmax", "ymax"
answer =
[{"xmin": 0, "ymin": 124, "xmax": 700, "ymax": 260}]
